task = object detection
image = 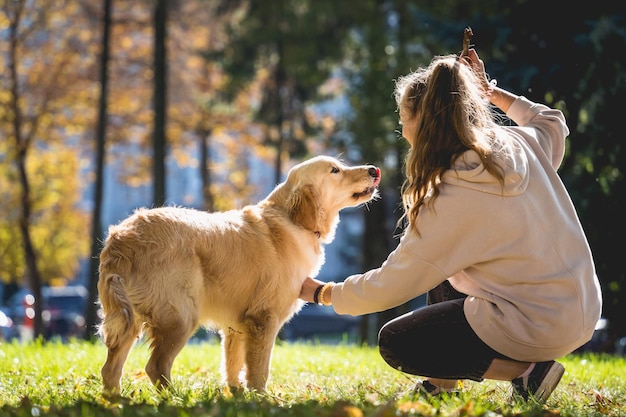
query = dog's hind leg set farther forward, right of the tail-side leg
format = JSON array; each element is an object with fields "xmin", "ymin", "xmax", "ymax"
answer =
[{"xmin": 146, "ymin": 309, "xmax": 198, "ymax": 388}]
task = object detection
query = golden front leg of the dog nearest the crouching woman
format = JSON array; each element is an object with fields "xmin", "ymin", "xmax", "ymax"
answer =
[{"xmin": 240, "ymin": 314, "xmax": 280, "ymax": 392}]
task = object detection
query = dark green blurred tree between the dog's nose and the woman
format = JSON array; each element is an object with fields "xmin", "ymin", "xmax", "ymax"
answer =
[{"xmin": 340, "ymin": 0, "xmax": 409, "ymax": 344}]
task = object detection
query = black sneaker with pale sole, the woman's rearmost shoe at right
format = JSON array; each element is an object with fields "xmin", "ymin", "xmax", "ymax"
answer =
[{"xmin": 511, "ymin": 361, "xmax": 565, "ymax": 402}]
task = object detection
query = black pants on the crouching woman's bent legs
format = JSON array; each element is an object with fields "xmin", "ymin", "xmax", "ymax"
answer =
[{"xmin": 378, "ymin": 281, "xmax": 508, "ymax": 381}]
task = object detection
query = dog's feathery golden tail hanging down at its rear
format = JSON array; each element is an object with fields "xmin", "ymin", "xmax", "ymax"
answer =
[{"xmin": 98, "ymin": 270, "xmax": 139, "ymax": 348}]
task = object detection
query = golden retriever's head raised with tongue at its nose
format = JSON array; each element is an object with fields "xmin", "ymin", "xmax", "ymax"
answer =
[{"xmin": 272, "ymin": 156, "xmax": 380, "ymax": 243}]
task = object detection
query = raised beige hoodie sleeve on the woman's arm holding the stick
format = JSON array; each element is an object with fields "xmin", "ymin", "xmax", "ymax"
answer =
[{"xmin": 507, "ymin": 96, "xmax": 569, "ymax": 171}]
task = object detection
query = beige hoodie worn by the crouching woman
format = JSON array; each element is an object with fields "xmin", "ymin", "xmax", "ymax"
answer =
[{"xmin": 332, "ymin": 97, "xmax": 602, "ymax": 361}]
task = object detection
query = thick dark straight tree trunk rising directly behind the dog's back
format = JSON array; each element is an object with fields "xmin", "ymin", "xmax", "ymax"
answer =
[{"xmin": 153, "ymin": 0, "xmax": 167, "ymax": 207}]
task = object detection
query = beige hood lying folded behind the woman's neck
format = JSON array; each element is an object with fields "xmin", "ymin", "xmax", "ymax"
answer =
[{"xmin": 442, "ymin": 144, "xmax": 529, "ymax": 196}]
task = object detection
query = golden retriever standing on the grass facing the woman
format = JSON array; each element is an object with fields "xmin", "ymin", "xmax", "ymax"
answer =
[{"xmin": 98, "ymin": 156, "xmax": 380, "ymax": 396}]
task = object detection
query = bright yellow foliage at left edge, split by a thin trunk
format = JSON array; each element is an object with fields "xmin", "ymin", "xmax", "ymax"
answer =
[{"xmin": 0, "ymin": 147, "xmax": 89, "ymax": 281}]
